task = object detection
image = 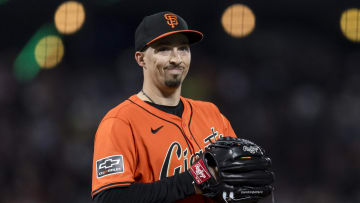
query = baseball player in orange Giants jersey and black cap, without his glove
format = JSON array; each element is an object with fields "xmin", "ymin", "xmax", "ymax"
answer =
[{"xmin": 91, "ymin": 12, "xmax": 266, "ymax": 203}]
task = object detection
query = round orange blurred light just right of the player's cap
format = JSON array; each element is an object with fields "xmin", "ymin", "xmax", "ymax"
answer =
[{"xmin": 221, "ymin": 4, "xmax": 255, "ymax": 37}]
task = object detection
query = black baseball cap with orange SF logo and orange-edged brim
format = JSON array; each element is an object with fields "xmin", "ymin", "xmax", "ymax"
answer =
[{"xmin": 135, "ymin": 11, "xmax": 203, "ymax": 51}]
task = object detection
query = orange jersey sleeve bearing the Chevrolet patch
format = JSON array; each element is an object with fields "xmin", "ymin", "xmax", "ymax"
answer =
[{"xmin": 91, "ymin": 118, "xmax": 137, "ymax": 197}]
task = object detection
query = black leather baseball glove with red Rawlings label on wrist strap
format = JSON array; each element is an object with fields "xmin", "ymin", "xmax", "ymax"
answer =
[{"xmin": 189, "ymin": 137, "xmax": 274, "ymax": 203}]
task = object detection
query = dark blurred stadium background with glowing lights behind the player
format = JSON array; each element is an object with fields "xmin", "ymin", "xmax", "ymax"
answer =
[{"xmin": 0, "ymin": 0, "xmax": 360, "ymax": 203}]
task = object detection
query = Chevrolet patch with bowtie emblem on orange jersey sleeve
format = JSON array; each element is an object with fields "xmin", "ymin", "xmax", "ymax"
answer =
[{"xmin": 96, "ymin": 155, "xmax": 124, "ymax": 178}]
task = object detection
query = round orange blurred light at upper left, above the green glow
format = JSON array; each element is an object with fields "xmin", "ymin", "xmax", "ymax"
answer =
[{"xmin": 55, "ymin": 1, "xmax": 85, "ymax": 34}]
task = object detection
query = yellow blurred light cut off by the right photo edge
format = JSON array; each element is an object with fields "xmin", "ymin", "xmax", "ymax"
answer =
[{"xmin": 340, "ymin": 8, "xmax": 360, "ymax": 42}]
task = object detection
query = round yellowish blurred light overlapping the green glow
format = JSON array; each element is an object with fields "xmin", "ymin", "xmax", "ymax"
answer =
[{"xmin": 35, "ymin": 35, "xmax": 64, "ymax": 68}]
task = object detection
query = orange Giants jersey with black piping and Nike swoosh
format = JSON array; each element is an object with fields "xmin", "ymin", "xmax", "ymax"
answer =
[{"xmin": 91, "ymin": 95, "xmax": 236, "ymax": 202}]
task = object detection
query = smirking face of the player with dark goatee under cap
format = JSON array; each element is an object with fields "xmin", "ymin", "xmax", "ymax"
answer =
[{"xmin": 144, "ymin": 34, "xmax": 191, "ymax": 88}]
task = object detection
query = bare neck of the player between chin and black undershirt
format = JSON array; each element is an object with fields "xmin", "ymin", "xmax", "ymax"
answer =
[{"xmin": 137, "ymin": 85, "xmax": 181, "ymax": 106}]
